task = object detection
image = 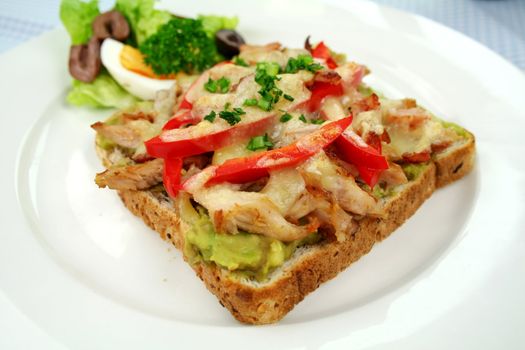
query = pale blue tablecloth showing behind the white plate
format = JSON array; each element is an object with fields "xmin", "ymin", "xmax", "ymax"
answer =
[{"xmin": 0, "ymin": 0, "xmax": 525, "ymax": 70}]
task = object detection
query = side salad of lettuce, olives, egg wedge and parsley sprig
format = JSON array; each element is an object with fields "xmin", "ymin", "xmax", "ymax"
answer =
[{"xmin": 60, "ymin": 0, "xmax": 244, "ymax": 108}]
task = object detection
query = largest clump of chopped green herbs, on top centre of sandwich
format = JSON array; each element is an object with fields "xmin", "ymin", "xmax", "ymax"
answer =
[{"xmin": 255, "ymin": 62, "xmax": 283, "ymax": 111}]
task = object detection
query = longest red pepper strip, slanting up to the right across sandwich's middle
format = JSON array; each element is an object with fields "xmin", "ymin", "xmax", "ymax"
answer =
[{"xmin": 201, "ymin": 116, "xmax": 352, "ymax": 185}]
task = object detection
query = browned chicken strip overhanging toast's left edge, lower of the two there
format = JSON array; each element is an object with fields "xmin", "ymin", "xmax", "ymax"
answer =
[{"xmin": 95, "ymin": 159, "xmax": 164, "ymax": 190}]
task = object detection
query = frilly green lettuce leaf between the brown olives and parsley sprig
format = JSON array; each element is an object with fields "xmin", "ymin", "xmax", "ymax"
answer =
[{"xmin": 115, "ymin": 0, "xmax": 173, "ymax": 45}]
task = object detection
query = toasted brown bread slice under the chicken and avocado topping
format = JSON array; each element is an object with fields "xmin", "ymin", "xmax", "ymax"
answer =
[{"xmin": 97, "ymin": 131, "xmax": 475, "ymax": 324}]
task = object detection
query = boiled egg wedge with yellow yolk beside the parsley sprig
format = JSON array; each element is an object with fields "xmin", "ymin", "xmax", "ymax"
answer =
[{"xmin": 100, "ymin": 38, "xmax": 175, "ymax": 100}]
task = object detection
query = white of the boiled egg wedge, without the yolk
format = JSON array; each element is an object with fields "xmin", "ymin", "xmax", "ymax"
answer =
[{"xmin": 100, "ymin": 38, "xmax": 175, "ymax": 100}]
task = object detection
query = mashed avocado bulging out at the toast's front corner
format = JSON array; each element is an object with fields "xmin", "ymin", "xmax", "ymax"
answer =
[{"xmin": 184, "ymin": 213, "xmax": 320, "ymax": 280}]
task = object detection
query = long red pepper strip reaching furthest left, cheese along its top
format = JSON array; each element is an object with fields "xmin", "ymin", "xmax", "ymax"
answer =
[{"xmin": 145, "ymin": 115, "xmax": 274, "ymax": 158}]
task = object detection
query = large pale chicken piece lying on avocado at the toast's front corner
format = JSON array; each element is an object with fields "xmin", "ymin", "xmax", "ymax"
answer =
[{"xmin": 193, "ymin": 185, "xmax": 317, "ymax": 242}]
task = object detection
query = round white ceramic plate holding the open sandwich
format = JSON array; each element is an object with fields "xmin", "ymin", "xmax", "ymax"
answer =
[{"xmin": 0, "ymin": 1, "xmax": 525, "ymax": 349}]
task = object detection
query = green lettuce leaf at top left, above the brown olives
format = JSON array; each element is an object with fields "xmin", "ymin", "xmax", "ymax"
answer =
[{"xmin": 60, "ymin": 0, "xmax": 100, "ymax": 45}]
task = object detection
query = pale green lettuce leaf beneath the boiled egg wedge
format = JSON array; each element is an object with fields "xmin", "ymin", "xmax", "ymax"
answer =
[{"xmin": 66, "ymin": 71, "xmax": 137, "ymax": 108}]
